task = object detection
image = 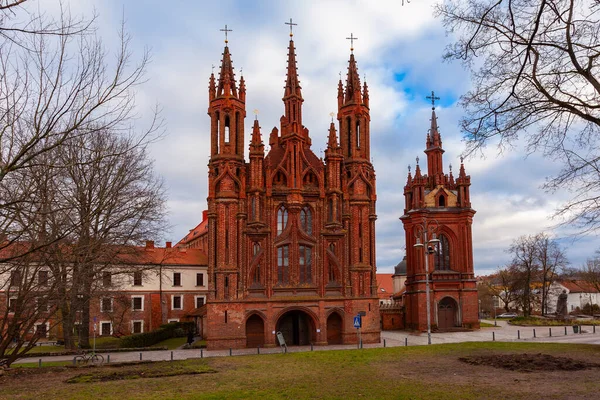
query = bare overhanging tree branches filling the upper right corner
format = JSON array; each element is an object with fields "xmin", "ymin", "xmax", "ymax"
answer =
[{"xmin": 436, "ymin": 0, "xmax": 600, "ymax": 232}]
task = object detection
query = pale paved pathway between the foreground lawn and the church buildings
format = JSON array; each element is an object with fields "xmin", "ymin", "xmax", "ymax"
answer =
[{"xmin": 15, "ymin": 321, "xmax": 600, "ymax": 364}]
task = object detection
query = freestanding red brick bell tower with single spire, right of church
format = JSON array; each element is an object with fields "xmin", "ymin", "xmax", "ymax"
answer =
[{"xmin": 400, "ymin": 92, "xmax": 479, "ymax": 331}]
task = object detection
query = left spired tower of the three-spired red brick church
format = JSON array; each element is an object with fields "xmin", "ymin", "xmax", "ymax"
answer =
[{"xmin": 207, "ymin": 27, "xmax": 246, "ymax": 314}]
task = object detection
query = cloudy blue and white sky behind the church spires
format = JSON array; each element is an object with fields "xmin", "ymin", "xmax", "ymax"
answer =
[{"xmin": 38, "ymin": 0, "xmax": 600, "ymax": 275}]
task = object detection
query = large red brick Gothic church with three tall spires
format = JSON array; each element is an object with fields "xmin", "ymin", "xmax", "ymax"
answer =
[{"xmin": 183, "ymin": 30, "xmax": 380, "ymax": 349}]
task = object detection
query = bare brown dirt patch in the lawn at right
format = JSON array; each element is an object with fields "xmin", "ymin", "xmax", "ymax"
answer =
[{"xmin": 459, "ymin": 353, "xmax": 600, "ymax": 372}]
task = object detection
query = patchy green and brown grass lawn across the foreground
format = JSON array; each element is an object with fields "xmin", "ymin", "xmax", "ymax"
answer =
[{"xmin": 0, "ymin": 342, "xmax": 600, "ymax": 400}]
